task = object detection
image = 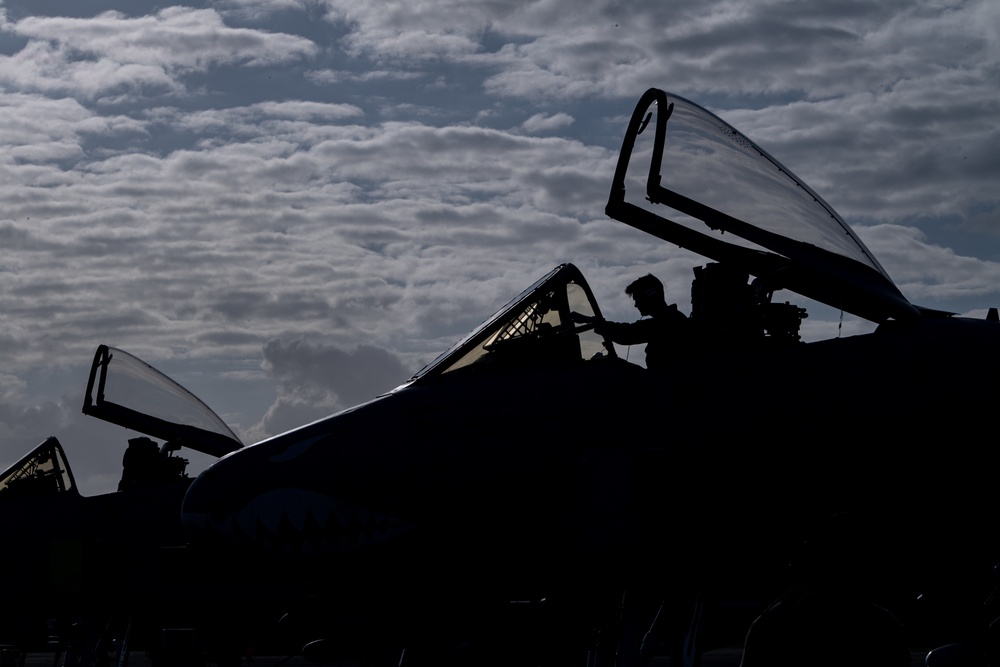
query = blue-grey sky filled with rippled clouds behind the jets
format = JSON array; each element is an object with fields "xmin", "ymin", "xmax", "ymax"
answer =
[{"xmin": 0, "ymin": 0, "xmax": 1000, "ymax": 493}]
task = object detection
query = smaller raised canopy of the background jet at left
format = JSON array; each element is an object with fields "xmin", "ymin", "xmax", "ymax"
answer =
[{"xmin": 83, "ymin": 345, "xmax": 243, "ymax": 456}]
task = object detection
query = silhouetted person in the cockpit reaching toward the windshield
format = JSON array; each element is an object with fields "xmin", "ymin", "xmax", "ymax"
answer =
[{"xmin": 595, "ymin": 274, "xmax": 688, "ymax": 368}]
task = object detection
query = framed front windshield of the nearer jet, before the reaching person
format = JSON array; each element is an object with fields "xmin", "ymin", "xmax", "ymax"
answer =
[{"xmin": 413, "ymin": 264, "xmax": 616, "ymax": 380}]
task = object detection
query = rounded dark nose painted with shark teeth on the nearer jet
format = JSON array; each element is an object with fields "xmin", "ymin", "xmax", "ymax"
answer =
[{"xmin": 181, "ymin": 430, "xmax": 411, "ymax": 556}]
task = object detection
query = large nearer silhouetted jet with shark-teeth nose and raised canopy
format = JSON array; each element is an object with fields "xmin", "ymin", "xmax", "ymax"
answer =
[{"xmin": 0, "ymin": 89, "xmax": 1000, "ymax": 664}]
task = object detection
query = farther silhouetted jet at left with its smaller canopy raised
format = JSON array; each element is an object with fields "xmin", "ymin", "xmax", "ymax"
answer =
[{"xmin": 0, "ymin": 345, "xmax": 242, "ymax": 667}]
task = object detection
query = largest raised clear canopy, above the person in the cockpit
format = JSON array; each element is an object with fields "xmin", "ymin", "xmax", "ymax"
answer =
[{"xmin": 606, "ymin": 89, "xmax": 919, "ymax": 322}]
